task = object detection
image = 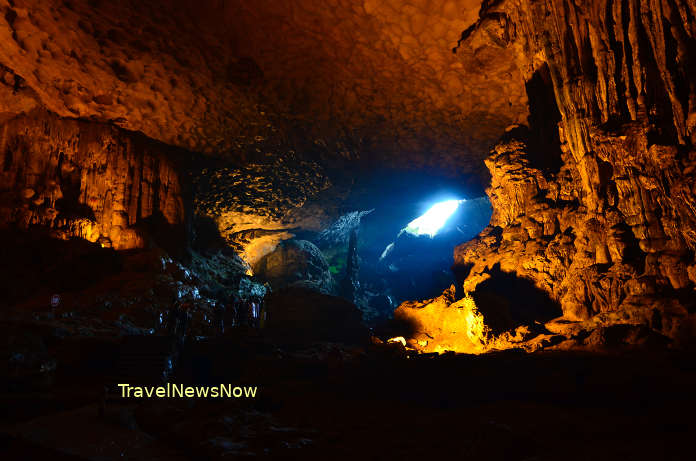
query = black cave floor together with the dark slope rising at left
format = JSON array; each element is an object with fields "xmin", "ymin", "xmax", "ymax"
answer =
[{"xmin": 0, "ymin": 234, "xmax": 696, "ymax": 460}]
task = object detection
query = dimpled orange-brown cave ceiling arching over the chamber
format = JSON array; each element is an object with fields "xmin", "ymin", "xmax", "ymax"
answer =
[{"xmin": 0, "ymin": 0, "xmax": 527, "ymax": 178}]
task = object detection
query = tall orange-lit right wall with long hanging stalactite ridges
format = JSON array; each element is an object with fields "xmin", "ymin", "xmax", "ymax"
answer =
[{"xmin": 455, "ymin": 0, "xmax": 696, "ymax": 338}]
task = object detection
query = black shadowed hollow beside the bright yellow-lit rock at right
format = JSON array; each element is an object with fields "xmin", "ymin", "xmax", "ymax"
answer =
[{"xmin": 473, "ymin": 264, "xmax": 563, "ymax": 334}]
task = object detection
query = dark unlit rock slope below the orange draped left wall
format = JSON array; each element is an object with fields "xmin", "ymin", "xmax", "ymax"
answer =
[{"xmin": 0, "ymin": 231, "xmax": 216, "ymax": 338}]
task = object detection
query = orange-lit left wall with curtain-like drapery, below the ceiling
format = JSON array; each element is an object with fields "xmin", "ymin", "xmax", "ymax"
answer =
[{"xmin": 0, "ymin": 110, "xmax": 190, "ymax": 250}]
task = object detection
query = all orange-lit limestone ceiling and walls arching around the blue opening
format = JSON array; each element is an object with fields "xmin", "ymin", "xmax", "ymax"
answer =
[{"xmin": 0, "ymin": 0, "xmax": 696, "ymax": 347}]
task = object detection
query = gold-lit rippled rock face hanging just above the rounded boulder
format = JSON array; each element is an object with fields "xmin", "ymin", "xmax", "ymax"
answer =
[{"xmin": 193, "ymin": 152, "xmax": 336, "ymax": 266}]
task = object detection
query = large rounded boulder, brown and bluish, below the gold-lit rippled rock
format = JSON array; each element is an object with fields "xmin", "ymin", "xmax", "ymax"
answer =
[{"xmin": 254, "ymin": 240, "xmax": 336, "ymax": 294}]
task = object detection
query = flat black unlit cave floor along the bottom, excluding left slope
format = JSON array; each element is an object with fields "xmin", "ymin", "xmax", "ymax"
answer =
[{"xmin": 0, "ymin": 330, "xmax": 696, "ymax": 460}]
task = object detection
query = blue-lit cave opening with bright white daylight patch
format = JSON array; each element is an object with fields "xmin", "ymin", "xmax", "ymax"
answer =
[{"xmin": 280, "ymin": 170, "xmax": 492, "ymax": 327}]
